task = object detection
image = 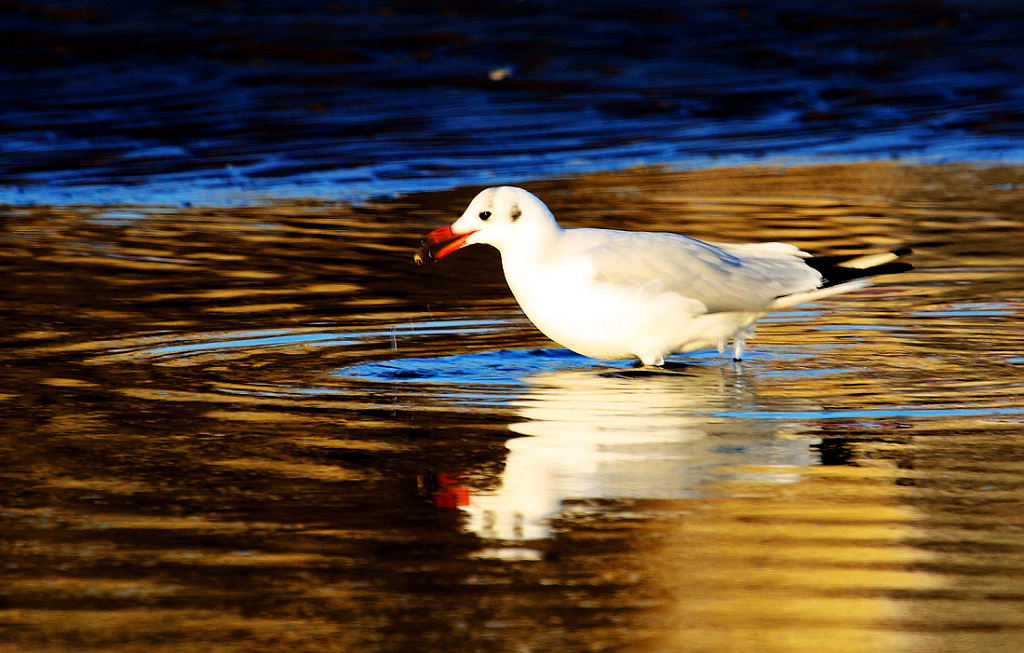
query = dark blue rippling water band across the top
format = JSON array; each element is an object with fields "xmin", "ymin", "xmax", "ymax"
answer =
[{"xmin": 0, "ymin": 0, "xmax": 1024, "ymax": 204}]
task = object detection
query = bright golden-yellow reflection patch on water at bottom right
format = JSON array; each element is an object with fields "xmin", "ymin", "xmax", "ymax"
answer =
[{"xmin": 650, "ymin": 468, "xmax": 945, "ymax": 651}]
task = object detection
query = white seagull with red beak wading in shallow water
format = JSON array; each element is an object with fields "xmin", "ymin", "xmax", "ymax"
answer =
[{"xmin": 414, "ymin": 186, "xmax": 912, "ymax": 366}]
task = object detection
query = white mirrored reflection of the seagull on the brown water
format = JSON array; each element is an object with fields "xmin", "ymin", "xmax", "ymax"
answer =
[{"xmin": 462, "ymin": 366, "xmax": 817, "ymax": 540}]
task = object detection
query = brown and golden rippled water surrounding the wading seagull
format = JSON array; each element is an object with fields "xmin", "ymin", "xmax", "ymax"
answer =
[{"xmin": 0, "ymin": 164, "xmax": 1024, "ymax": 651}]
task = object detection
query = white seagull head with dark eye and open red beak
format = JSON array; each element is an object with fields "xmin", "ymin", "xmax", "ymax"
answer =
[{"xmin": 415, "ymin": 186, "xmax": 561, "ymax": 265}]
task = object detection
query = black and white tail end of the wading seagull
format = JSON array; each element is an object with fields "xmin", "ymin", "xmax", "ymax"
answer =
[{"xmin": 772, "ymin": 247, "xmax": 913, "ymax": 309}]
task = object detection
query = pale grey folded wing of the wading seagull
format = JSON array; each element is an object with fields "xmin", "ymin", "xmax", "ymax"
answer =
[{"xmin": 566, "ymin": 229, "xmax": 821, "ymax": 313}]
